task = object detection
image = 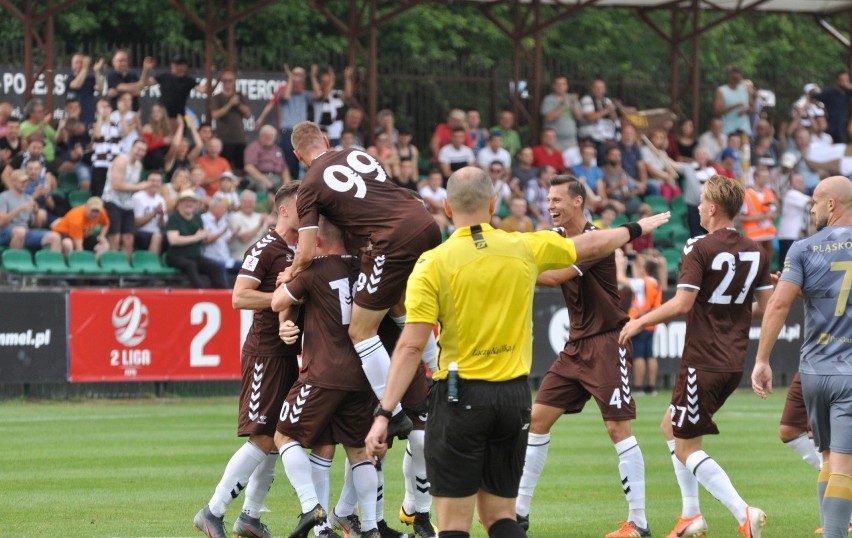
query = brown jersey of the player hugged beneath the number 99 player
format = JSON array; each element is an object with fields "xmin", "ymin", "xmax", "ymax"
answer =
[{"xmin": 286, "ymin": 256, "xmax": 370, "ymax": 390}]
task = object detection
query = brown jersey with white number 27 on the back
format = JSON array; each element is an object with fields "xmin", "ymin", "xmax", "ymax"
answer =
[{"xmin": 677, "ymin": 228, "xmax": 772, "ymax": 372}]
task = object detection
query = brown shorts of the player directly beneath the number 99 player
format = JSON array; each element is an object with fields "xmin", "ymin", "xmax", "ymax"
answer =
[{"xmin": 278, "ymin": 380, "xmax": 376, "ymax": 448}]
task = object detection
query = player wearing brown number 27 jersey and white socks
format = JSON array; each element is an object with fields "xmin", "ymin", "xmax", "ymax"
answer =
[{"xmin": 620, "ymin": 175, "xmax": 772, "ymax": 538}]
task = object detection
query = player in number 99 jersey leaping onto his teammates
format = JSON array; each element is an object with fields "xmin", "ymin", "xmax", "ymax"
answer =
[{"xmin": 285, "ymin": 122, "xmax": 441, "ymax": 437}]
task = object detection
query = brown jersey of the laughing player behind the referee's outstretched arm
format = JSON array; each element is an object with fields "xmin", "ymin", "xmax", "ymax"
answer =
[{"xmin": 559, "ymin": 222, "xmax": 629, "ymax": 340}]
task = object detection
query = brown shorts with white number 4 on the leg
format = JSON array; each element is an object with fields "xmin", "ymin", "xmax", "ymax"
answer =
[{"xmin": 535, "ymin": 330, "xmax": 636, "ymax": 421}]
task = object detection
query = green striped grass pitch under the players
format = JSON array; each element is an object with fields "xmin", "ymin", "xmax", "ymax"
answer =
[{"xmin": 0, "ymin": 391, "xmax": 819, "ymax": 538}]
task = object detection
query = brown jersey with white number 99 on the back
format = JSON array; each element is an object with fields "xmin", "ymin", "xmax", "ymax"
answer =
[{"xmin": 296, "ymin": 149, "xmax": 435, "ymax": 253}]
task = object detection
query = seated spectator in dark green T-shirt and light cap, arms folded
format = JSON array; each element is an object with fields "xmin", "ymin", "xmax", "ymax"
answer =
[{"xmin": 166, "ymin": 190, "xmax": 228, "ymax": 289}]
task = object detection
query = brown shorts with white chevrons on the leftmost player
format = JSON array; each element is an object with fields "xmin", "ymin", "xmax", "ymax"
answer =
[{"xmin": 237, "ymin": 354, "xmax": 299, "ymax": 437}]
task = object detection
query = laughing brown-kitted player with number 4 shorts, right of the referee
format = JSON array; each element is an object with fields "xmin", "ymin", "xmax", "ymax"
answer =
[{"xmin": 516, "ymin": 175, "xmax": 651, "ymax": 537}]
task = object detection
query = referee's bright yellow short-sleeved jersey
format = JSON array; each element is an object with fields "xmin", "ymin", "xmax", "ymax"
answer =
[{"xmin": 405, "ymin": 224, "xmax": 577, "ymax": 382}]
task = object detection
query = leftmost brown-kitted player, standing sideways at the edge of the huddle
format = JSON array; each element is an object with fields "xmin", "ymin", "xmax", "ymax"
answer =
[{"xmin": 194, "ymin": 184, "xmax": 300, "ymax": 538}]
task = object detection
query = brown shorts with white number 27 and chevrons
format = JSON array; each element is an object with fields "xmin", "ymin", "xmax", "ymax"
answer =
[{"xmin": 669, "ymin": 363, "xmax": 743, "ymax": 439}]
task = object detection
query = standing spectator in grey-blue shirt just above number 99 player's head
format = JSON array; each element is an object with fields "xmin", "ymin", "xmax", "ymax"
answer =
[{"xmin": 257, "ymin": 63, "xmax": 314, "ymax": 179}]
